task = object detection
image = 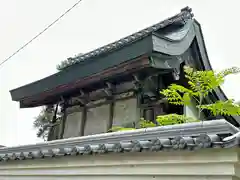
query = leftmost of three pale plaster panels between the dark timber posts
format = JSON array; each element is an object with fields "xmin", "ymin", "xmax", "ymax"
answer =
[{"xmin": 63, "ymin": 111, "xmax": 82, "ymax": 138}]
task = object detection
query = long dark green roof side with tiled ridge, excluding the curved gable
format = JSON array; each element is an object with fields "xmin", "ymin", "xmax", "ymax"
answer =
[{"xmin": 10, "ymin": 7, "xmax": 192, "ymax": 107}]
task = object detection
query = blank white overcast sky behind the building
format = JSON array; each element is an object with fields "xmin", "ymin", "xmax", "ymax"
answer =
[{"xmin": 0, "ymin": 0, "xmax": 240, "ymax": 146}]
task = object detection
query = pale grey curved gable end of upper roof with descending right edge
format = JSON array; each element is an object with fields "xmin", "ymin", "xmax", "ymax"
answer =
[{"xmin": 153, "ymin": 19, "xmax": 240, "ymax": 127}]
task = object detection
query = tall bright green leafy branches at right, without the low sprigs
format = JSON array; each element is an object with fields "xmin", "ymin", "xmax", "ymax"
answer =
[{"xmin": 160, "ymin": 66, "xmax": 240, "ymax": 120}]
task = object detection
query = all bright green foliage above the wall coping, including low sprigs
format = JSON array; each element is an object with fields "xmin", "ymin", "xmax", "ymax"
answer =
[{"xmin": 110, "ymin": 66, "xmax": 240, "ymax": 131}]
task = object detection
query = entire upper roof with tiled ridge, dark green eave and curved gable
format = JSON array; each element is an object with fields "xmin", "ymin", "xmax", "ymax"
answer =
[{"xmin": 7, "ymin": 8, "xmax": 240, "ymax": 127}]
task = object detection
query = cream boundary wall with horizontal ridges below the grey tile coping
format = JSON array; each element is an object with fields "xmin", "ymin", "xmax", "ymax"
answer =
[{"xmin": 0, "ymin": 149, "xmax": 240, "ymax": 180}]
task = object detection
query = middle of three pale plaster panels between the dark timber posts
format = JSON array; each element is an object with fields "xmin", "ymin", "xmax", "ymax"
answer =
[{"xmin": 84, "ymin": 104, "xmax": 110, "ymax": 136}]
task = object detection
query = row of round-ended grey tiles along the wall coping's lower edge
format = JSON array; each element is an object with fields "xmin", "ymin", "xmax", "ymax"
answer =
[{"xmin": 0, "ymin": 134, "xmax": 240, "ymax": 161}]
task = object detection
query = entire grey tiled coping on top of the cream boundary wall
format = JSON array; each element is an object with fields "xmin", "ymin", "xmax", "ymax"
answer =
[{"xmin": 0, "ymin": 120, "xmax": 240, "ymax": 162}]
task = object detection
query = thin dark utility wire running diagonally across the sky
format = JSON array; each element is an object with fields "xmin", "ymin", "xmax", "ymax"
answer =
[{"xmin": 0, "ymin": 0, "xmax": 82, "ymax": 68}]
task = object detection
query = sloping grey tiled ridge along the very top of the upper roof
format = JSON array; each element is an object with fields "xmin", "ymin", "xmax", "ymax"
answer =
[{"xmin": 57, "ymin": 7, "xmax": 193, "ymax": 68}]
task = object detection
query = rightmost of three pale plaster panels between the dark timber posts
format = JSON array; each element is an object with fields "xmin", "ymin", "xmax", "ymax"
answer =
[{"xmin": 113, "ymin": 98, "xmax": 138, "ymax": 126}]
